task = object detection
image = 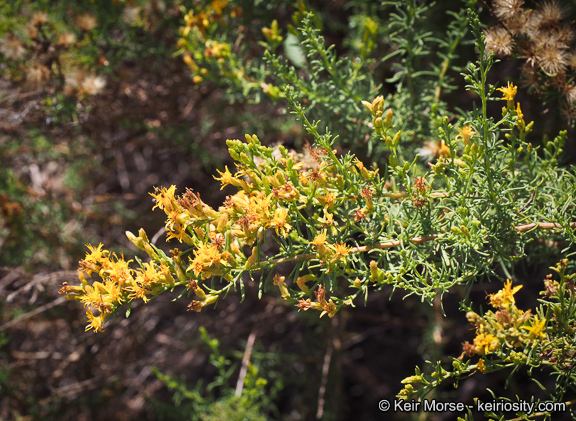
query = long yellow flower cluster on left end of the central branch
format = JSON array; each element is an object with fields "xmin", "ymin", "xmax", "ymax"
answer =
[{"xmin": 60, "ymin": 136, "xmax": 376, "ymax": 331}]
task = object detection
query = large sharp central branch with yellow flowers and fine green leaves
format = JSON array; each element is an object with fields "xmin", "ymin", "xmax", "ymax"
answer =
[{"xmin": 63, "ymin": 5, "xmax": 575, "ymax": 327}]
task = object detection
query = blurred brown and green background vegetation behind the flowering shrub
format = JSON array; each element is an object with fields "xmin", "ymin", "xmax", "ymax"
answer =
[{"xmin": 0, "ymin": 0, "xmax": 572, "ymax": 420}]
